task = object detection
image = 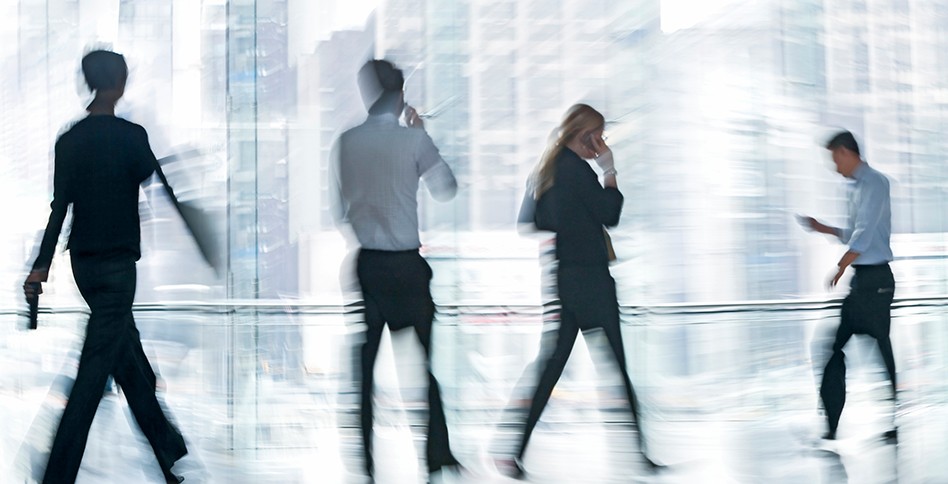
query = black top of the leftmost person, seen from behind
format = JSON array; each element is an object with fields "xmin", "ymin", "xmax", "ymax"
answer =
[{"xmin": 56, "ymin": 115, "xmax": 154, "ymax": 254}]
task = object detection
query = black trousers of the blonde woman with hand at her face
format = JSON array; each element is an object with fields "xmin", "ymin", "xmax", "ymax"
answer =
[{"xmin": 517, "ymin": 264, "xmax": 645, "ymax": 458}]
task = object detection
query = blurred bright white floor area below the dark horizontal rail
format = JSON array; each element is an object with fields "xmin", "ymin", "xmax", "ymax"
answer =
[{"xmin": 0, "ymin": 305, "xmax": 948, "ymax": 483}]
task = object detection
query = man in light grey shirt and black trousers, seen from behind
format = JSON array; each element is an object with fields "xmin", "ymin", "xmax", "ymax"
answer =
[{"xmin": 333, "ymin": 60, "xmax": 459, "ymax": 476}]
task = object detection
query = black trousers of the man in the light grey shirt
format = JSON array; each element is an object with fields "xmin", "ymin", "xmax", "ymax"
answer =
[{"xmin": 356, "ymin": 249, "xmax": 457, "ymax": 475}]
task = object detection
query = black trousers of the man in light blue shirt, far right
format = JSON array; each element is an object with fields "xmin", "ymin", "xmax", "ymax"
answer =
[{"xmin": 820, "ymin": 264, "xmax": 896, "ymax": 432}]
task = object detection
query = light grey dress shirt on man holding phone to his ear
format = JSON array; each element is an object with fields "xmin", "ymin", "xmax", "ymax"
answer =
[{"xmin": 333, "ymin": 113, "xmax": 457, "ymax": 251}]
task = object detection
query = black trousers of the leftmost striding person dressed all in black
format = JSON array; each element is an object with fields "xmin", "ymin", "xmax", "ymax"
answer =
[{"xmin": 43, "ymin": 254, "xmax": 188, "ymax": 484}]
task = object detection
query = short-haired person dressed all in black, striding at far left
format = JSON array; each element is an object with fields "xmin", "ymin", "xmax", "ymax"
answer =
[{"xmin": 24, "ymin": 50, "xmax": 188, "ymax": 484}]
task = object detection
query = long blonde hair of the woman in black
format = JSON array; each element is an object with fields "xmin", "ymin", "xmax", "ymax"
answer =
[{"xmin": 532, "ymin": 104, "xmax": 606, "ymax": 200}]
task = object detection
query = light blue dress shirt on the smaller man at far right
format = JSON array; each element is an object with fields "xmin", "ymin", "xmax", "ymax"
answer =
[{"xmin": 836, "ymin": 162, "xmax": 892, "ymax": 265}]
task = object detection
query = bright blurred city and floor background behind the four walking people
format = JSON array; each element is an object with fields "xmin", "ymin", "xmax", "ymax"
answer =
[{"xmin": 0, "ymin": 0, "xmax": 948, "ymax": 483}]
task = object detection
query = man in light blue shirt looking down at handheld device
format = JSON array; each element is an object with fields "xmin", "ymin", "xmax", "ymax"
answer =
[{"xmin": 801, "ymin": 131, "xmax": 897, "ymax": 441}]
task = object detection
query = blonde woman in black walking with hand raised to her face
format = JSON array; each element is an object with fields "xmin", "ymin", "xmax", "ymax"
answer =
[{"xmin": 515, "ymin": 104, "xmax": 654, "ymax": 477}]
